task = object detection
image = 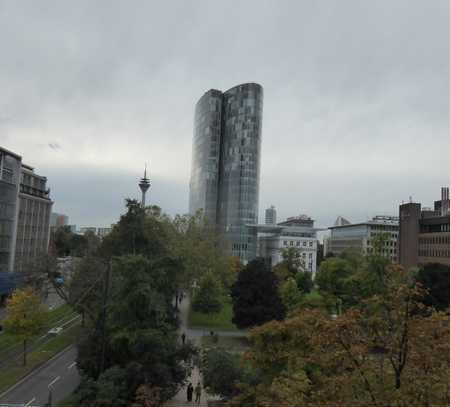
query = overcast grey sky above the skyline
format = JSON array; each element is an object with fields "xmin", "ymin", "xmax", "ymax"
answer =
[{"xmin": 0, "ymin": 0, "xmax": 450, "ymax": 226}]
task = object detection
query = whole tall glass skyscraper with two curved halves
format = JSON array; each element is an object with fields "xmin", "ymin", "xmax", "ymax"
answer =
[{"xmin": 189, "ymin": 83, "xmax": 263, "ymax": 262}]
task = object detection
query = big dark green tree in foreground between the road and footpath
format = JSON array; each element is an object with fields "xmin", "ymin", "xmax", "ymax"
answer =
[{"xmin": 78, "ymin": 255, "xmax": 193, "ymax": 402}]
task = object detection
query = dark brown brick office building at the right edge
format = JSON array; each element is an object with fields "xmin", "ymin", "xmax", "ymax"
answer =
[{"xmin": 399, "ymin": 187, "xmax": 450, "ymax": 268}]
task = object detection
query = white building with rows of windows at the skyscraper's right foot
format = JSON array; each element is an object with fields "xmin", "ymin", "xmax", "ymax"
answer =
[{"xmin": 251, "ymin": 215, "xmax": 319, "ymax": 277}]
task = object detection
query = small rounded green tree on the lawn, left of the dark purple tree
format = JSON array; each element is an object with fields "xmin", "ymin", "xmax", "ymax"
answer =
[{"xmin": 192, "ymin": 271, "xmax": 223, "ymax": 314}]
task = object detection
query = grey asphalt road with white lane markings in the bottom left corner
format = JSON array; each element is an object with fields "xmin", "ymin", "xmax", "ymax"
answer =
[{"xmin": 0, "ymin": 347, "xmax": 80, "ymax": 406}]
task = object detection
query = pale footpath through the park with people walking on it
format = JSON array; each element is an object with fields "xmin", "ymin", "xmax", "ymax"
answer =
[{"xmin": 164, "ymin": 296, "xmax": 208, "ymax": 407}]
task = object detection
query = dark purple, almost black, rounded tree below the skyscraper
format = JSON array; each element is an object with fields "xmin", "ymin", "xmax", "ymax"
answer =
[{"xmin": 231, "ymin": 259, "xmax": 285, "ymax": 328}]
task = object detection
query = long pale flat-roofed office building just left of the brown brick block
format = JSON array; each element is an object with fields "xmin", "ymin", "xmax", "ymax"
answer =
[{"xmin": 325, "ymin": 216, "xmax": 399, "ymax": 263}]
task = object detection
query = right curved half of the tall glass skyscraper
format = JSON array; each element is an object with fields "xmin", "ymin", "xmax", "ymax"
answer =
[{"xmin": 218, "ymin": 83, "xmax": 263, "ymax": 261}]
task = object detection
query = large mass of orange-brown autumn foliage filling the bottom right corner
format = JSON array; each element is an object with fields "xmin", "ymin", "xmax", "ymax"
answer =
[{"xmin": 231, "ymin": 266, "xmax": 450, "ymax": 407}]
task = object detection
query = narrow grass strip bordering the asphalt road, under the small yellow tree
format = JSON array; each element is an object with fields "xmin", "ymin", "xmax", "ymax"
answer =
[{"xmin": 0, "ymin": 325, "xmax": 81, "ymax": 393}]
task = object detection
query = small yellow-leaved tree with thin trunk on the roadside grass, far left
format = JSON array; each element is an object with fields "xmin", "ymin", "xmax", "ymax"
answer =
[{"xmin": 3, "ymin": 288, "xmax": 46, "ymax": 366}]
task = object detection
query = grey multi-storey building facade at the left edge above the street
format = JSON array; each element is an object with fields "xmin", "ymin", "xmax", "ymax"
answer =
[{"xmin": 0, "ymin": 147, "xmax": 52, "ymax": 272}]
